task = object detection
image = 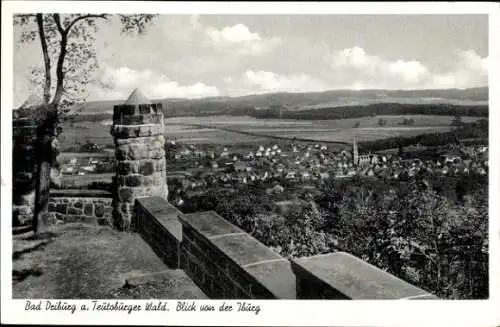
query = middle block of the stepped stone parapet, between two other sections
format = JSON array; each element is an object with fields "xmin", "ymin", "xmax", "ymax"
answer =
[{"xmin": 180, "ymin": 212, "xmax": 296, "ymax": 299}]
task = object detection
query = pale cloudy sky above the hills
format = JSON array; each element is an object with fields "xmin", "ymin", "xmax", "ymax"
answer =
[{"xmin": 14, "ymin": 14, "xmax": 488, "ymax": 105}]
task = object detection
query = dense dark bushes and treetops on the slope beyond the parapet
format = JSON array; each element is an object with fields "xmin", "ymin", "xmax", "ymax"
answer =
[{"xmin": 182, "ymin": 175, "xmax": 488, "ymax": 299}]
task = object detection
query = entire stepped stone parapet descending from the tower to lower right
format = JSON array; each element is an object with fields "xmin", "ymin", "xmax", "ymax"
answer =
[{"xmin": 134, "ymin": 197, "xmax": 438, "ymax": 300}]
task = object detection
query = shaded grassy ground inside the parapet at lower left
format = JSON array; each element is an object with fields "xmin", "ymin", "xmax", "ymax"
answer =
[{"xmin": 12, "ymin": 224, "xmax": 205, "ymax": 299}]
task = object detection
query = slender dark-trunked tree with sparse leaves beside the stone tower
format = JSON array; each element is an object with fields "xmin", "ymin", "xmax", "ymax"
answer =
[{"xmin": 14, "ymin": 13, "xmax": 156, "ymax": 232}]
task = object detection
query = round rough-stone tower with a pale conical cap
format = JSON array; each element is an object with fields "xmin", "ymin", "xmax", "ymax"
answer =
[{"xmin": 111, "ymin": 89, "xmax": 168, "ymax": 230}]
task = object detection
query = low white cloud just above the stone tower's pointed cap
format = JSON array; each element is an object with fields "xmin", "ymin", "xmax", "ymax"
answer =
[{"xmin": 89, "ymin": 66, "xmax": 220, "ymax": 99}]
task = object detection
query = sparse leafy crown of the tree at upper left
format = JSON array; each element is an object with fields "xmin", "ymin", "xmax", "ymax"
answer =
[{"xmin": 14, "ymin": 13, "xmax": 155, "ymax": 119}]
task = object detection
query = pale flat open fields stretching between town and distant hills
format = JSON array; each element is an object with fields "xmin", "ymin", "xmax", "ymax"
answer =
[{"xmin": 60, "ymin": 115, "xmax": 480, "ymax": 150}]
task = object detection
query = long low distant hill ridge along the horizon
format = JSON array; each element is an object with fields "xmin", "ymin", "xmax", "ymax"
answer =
[{"xmin": 67, "ymin": 87, "xmax": 488, "ymax": 116}]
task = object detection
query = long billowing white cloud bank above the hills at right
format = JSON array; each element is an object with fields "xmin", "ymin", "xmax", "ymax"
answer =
[{"xmin": 223, "ymin": 47, "xmax": 488, "ymax": 95}]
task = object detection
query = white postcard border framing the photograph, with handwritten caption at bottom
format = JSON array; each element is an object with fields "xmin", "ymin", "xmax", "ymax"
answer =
[{"xmin": 1, "ymin": 1, "xmax": 500, "ymax": 327}]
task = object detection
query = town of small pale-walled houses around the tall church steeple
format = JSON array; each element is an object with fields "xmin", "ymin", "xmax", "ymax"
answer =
[{"xmin": 164, "ymin": 138, "xmax": 488, "ymax": 205}]
